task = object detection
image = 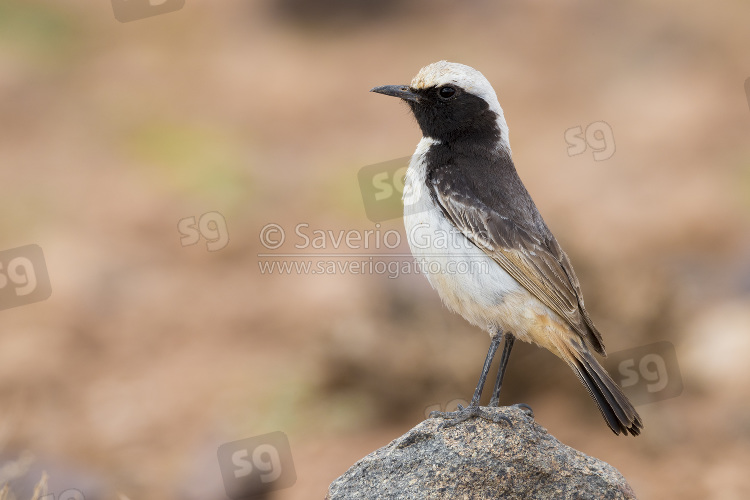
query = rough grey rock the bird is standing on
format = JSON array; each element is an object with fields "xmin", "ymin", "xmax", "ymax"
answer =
[{"xmin": 326, "ymin": 406, "xmax": 635, "ymax": 500}]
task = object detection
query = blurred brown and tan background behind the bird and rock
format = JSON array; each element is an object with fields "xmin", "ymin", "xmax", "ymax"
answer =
[{"xmin": 0, "ymin": 0, "xmax": 750, "ymax": 500}]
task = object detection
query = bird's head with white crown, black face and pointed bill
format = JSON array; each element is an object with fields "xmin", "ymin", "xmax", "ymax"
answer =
[{"xmin": 371, "ymin": 61, "xmax": 510, "ymax": 154}]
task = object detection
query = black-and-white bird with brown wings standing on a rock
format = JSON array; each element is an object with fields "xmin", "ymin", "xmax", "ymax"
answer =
[{"xmin": 371, "ymin": 60, "xmax": 643, "ymax": 436}]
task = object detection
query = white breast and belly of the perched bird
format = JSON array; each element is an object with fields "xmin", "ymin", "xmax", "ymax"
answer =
[{"xmin": 404, "ymin": 138, "xmax": 537, "ymax": 336}]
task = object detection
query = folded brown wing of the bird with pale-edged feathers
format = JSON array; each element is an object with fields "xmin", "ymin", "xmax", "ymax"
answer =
[{"xmin": 430, "ymin": 175, "xmax": 604, "ymax": 354}]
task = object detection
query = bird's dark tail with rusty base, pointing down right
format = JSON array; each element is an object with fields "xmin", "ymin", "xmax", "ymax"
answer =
[{"xmin": 568, "ymin": 347, "xmax": 643, "ymax": 436}]
